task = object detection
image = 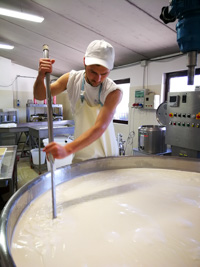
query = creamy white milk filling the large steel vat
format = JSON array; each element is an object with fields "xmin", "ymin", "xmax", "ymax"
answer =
[{"xmin": 11, "ymin": 168, "xmax": 200, "ymax": 267}]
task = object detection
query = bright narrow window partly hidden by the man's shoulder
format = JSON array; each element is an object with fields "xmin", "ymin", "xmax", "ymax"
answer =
[{"xmin": 113, "ymin": 78, "xmax": 130, "ymax": 124}]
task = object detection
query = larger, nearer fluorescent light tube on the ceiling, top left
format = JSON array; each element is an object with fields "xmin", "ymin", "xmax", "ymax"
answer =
[{"xmin": 0, "ymin": 8, "xmax": 44, "ymax": 23}]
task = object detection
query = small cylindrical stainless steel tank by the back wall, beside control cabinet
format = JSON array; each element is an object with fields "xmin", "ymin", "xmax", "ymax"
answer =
[{"xmin": 138, "ymin": 125, "xmax": 167, "ymax": 154}]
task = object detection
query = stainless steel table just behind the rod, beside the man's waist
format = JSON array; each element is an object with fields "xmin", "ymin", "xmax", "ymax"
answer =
[{"xmin": 29, "ymin": 121, "xmax": 74, "ymax": 174}]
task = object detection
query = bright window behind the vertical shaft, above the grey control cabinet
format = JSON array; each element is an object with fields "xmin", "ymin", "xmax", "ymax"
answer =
[{"xmin": 165, "ymin": 69, "xmax": 200, "ymax": 101}]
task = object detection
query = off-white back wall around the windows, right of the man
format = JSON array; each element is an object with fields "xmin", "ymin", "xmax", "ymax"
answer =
[{"xmin": 109, "ymin": 55, "xmax": 200, "ymax": 155}]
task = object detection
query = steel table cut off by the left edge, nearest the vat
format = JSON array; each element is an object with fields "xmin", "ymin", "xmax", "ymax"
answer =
[{"xmin": 0, "ymin": 145, "xmax": 17, "ymax": 207}]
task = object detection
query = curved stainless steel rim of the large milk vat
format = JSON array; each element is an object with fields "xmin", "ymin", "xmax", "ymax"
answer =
[{"xmin": 0, "ymin": 156, "xmax": 200, "ymax": 267}]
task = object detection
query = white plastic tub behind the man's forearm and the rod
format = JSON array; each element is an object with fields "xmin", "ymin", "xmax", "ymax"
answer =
[{"xmin": 43, "ymin": 136, "xmax": 73, "ymax": 171}]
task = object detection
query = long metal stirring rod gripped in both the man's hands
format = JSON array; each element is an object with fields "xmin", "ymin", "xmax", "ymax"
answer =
[{"xmin": 43, "ymin": 45, "xmax": 57, "ymax": 219}]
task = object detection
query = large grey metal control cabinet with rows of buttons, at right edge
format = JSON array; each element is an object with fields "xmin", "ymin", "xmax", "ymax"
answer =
[{"xmin": 166, "ymin": 91, "xmax": 200, "ymax": 156}]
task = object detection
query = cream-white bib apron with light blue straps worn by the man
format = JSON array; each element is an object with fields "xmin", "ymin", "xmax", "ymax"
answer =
[{"xmin": 72, "ymin": 75, "xmax": 119, "ymax": 163}]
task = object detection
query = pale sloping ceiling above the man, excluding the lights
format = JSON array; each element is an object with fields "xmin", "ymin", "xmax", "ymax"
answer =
[{"xmin": 0, "ymin": 0, "xmax": 179, "ymax": 76}]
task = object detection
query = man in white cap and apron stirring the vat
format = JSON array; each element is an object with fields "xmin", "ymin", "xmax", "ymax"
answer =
[{"xmin": 34, "ymin": 40, "xmax": 122, "ymax": 163}]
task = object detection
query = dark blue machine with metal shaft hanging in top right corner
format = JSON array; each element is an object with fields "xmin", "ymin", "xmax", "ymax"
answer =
[{"xmin": 160, "ymin": 0, "xmax": 200, "ymax": 85}]
